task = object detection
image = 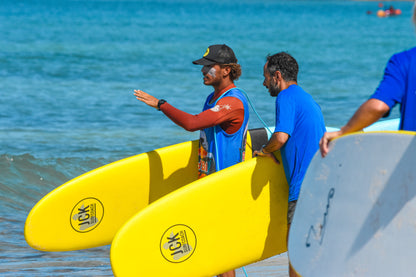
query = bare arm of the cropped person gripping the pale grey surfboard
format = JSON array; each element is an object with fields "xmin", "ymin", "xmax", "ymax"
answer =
[{"xmin": 319, "ymin": 99, "xmax": 390, "ymax": 157}]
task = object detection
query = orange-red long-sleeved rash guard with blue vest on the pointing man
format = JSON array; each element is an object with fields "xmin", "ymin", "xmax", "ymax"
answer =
[{"xmin": 160, "ymin": 85, "xmax": 249, "ymax": 178}]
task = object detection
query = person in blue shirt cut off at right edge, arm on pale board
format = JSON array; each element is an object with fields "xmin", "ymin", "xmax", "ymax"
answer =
[{"xmin": 320, "ymin": 4, "xmax": 416, "ymax": 157}]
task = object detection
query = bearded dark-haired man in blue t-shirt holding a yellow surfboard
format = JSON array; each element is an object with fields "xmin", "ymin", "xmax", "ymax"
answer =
[{"xmin": 254, "ymin": 52, "xmax": 325, "ymax": 276}]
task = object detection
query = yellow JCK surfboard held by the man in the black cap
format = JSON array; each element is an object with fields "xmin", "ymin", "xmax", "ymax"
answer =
[{"xmin": 25, "ymin": 128, "xmax": 267, "ymax": 251}]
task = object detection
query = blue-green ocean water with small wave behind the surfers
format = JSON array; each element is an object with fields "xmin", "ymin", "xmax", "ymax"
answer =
[{"xmin": 0, "ymin": 0, "xmax": 416, "ymax": 276}]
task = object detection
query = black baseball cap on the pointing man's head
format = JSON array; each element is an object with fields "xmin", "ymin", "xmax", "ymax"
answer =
[{"xmin": 192, "ymin": 44, "xmax": 237, "ymax": 65}]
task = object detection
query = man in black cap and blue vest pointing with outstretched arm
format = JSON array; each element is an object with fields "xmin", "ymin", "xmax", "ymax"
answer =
[{"xmin": 134, "ymin": 44, "xmax": 249, "ymax": 277}]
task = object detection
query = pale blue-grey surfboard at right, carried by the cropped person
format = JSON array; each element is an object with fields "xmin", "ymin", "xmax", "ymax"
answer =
[{"xmin": 289, "ymin": 132, "xmax": 416, "ymax": 277}]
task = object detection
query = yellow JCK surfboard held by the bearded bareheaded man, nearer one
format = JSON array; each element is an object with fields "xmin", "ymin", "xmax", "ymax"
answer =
[{"xmin": 111, "ymin": 154, "xmax": 288, "ymax": 277}]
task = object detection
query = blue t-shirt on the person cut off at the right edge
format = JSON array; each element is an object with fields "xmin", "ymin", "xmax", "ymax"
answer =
[{"xmin": 371, "ymin": 47, "xmax": 416, "ymax": 131}]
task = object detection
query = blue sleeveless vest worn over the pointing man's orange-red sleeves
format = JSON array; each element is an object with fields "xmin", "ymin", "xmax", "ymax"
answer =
[{"xmin": 198, "ymin": 88, "xmax": 249, "ymax": 178}]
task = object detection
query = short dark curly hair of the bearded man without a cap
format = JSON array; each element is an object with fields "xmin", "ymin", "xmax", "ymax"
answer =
[{"xmin": 267, "ymin": 52, "xmax": 299, "ymax": 82}]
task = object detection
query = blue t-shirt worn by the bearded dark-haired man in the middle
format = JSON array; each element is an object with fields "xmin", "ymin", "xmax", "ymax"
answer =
[{"xmin": 275, "ymin": 85, "xmax": 326, "ymax": 202}]
